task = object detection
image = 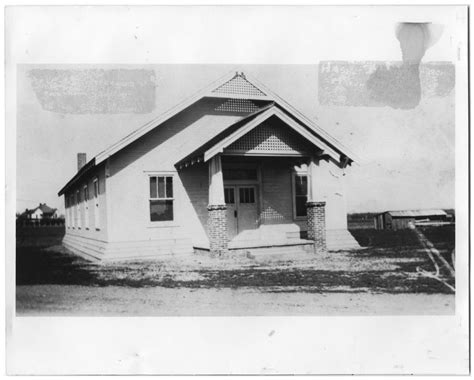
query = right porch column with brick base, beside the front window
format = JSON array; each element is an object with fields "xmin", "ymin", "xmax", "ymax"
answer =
[{"xmin": 306, "ymin": 157, "xmax": 326, "ymax": 253}]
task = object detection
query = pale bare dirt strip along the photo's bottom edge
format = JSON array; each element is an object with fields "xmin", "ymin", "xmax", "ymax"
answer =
[{"xmin": 17, "ymin": 285, "xmax": 454, "ymax": 316}]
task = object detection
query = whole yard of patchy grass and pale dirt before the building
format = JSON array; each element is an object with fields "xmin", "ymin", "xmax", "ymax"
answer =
[{"xmin": 16, "ymin": 230, "xmax": 455, "ymax": 316}]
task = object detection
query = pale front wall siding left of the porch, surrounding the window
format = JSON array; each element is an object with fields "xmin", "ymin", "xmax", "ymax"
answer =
[{"xmin": 104, "ymin": 100, "xmax": 242, "ymax": 242}]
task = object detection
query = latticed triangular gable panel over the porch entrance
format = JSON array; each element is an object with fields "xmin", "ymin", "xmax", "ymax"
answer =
[{"xmin": 226, "ymin": 123, "xmax": 311, "ymax": 154}]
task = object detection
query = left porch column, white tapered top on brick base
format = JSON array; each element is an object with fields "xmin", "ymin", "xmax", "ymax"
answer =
[{"xmin": 207, "ymin": 155, "xmax": 228, "ymax": 255}]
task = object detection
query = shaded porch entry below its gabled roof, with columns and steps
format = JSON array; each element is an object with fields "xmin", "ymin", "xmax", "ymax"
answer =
[{"xmin": 180, "ymin": 151, "xmax": 325, "ymax": 254}]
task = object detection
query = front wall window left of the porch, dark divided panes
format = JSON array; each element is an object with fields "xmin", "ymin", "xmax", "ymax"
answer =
[{"xmin": 150, "ymin": 176, "xmax": 174, "ymax": 222}]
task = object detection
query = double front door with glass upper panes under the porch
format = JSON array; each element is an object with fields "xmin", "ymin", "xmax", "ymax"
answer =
[{"xmin": 224, "ymin": 185, "xmax": 258, "ymax": 239}]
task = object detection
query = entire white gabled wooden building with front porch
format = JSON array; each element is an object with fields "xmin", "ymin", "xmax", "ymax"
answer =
[{"xmin": 59, "ymin": 72, "xmax": 357, "ymax": 260}]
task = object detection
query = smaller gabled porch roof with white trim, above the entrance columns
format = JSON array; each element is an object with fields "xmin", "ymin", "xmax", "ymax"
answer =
[{"xmin": 175, "ymin": 102, "xmax": 346, "ymax": 169}]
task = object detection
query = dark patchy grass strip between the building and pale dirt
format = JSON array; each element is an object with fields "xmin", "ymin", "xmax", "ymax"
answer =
[{"xmin": 17, "ymin": 243, "xmax": 449, "ymax": 293}]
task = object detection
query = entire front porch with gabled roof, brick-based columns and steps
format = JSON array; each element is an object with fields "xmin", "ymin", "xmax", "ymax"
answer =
[{"xmin": 175, "ymin": 104, "xmax": 350, "ymax": 254}]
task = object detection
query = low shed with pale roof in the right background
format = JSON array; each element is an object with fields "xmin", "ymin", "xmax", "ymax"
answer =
[{"xmin": 374, "ymin": 209, "xmax": 452, "ymax": 230}]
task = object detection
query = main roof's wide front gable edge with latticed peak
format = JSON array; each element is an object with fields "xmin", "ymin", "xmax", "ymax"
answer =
[{"xmin": 58, "ymin": 72, "xmax": 358, "ymax": 195}]
